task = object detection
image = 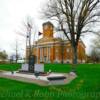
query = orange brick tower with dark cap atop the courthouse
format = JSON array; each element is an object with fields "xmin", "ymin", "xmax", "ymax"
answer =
[{"xmin": 43, "ymin": 22, "xmax": 54, "ymax": 38}]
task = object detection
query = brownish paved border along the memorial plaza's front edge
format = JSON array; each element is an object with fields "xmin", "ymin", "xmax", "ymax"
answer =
[{"xmin": 0, "ymin": 71, "xmax": 77, "ymax": 86}]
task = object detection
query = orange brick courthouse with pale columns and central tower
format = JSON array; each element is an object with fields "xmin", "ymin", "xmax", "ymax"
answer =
[{"xmin": 26, "ymin": 22, "xmax": 86, "ymax": 63}]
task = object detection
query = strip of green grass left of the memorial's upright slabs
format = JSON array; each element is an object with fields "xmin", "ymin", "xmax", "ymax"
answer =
[{"xmin": 0, "ymin": 64, "xmax": 21, "ymax": 71}]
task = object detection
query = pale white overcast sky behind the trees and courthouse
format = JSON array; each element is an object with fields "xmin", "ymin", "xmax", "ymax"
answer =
[{"xmin": 0, "ymin": 0, "xmax": 95, "ymax": 55}]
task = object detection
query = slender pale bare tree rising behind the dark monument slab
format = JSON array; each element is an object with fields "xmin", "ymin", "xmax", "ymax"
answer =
[{"xmin": 17, "ymin": 16, "xmax": 36, "ymax": 71}]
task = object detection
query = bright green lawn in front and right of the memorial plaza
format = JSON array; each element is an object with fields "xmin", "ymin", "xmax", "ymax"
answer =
[{"xmin": 0, "ymin": 64, "xmax": 100, "ymax": 100}]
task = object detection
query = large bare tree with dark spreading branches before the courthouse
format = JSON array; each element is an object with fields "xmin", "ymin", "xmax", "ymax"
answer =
[{"xmin": 42, "ymin": 0, "xmax": 100, "ymax": 67}]
